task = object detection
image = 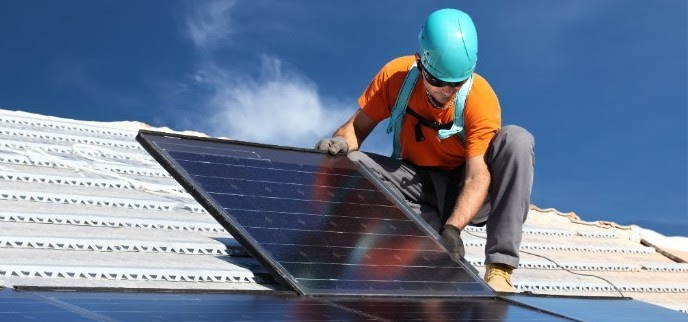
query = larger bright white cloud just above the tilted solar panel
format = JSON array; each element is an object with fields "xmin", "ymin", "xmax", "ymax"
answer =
[{"xmin": 196, "ymin": 56, "xmax": 355, "ymax": 148}]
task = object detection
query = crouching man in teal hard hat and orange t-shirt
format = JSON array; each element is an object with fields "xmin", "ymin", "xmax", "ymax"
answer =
[{"xmin": 316, "ymin": 9, "xmax": 534, "ymax": 292}]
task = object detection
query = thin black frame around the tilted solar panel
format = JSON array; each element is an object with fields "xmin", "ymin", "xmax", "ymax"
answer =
[{"xmin": 136, "ymin": 130, "xmax": 494, "ymax": 297}]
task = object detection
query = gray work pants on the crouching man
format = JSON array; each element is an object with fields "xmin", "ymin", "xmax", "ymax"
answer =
[{"xmin": 348, "ymin": 125, "xmax": 535, "ymax": 267}]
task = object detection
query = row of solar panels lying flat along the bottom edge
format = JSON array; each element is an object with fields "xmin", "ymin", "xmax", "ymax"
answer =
[{"xmin": 6, "ymin": 287, "xmax": 688, "ymax": 322}]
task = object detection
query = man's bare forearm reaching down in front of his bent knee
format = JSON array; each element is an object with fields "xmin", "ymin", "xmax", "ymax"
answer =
[{"xmin": 447, "ymin": 155, "xmax": 490, "ymax": 229}]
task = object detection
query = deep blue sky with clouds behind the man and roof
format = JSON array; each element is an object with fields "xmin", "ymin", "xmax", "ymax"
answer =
[{"xmin": 0, "ymin": 0, "xmax": 688, "ymax": 236}]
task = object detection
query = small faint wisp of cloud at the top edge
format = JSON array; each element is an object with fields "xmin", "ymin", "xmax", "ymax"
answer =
[{"xmin": 185, "ymin": 0, "xmax": 235, "ymax": 51}]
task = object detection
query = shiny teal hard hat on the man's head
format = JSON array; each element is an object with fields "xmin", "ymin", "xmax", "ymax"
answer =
[{"xmin": 418, "ymin": 9, "xmax": 478, "ymax": 83}]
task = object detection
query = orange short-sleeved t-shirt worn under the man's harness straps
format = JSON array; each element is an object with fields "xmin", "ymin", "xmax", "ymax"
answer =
[{"xmin": 358, "ymin": 56, "xmax": 501, "ymax": 169}]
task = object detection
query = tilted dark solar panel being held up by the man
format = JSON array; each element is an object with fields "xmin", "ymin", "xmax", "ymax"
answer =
[{"xmin": 137, "ymin": 131, "xmax": 493, "ymax": 296}]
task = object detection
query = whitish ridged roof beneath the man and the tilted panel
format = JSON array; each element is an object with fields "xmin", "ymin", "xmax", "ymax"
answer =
[{"xmin": 0, "ymin": 110, "xmax": 688, "ymax": 312}]
